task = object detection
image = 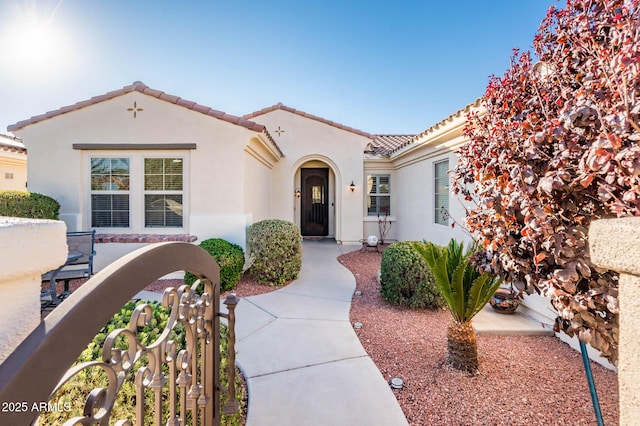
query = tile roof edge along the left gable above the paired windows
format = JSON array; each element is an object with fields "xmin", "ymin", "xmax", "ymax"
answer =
[{"xmin": 7, "ymin": 81, "xmax": 282, "ymax": 154}]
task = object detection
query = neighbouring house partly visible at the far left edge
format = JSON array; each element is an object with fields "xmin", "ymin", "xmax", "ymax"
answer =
[{"xmin": 0, "ymin": 133, "xmax": 27, "ymax": 191}]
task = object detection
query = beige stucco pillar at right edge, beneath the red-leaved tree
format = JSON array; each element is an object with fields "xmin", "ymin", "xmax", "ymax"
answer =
[{"xmin": 589, "ymin": 217, "xmax": 640, "ymax": 425}]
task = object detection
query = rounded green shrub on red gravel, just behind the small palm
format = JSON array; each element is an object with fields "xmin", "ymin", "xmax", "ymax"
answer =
[{"xmin": 380, "ymin": 241, "xmax": 444, "ymax": 309}]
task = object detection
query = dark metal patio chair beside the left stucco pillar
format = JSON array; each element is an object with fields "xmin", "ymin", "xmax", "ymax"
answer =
[{"xmin": 40, "ymin": 230, "xmax": 96, "ymax": 309}]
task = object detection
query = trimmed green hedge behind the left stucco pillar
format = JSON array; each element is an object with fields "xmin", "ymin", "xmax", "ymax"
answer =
[{"xmin": 0, "ymin": 191, "xmax": 60, "ymax": 220}]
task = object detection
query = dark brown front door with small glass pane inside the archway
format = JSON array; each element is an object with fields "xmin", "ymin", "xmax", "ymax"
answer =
[{"xmin": 300, "ymin": 169, "xmax": 329, "ymax": 236}]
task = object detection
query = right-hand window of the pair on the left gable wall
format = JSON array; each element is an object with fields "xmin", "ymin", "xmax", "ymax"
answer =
[{"xmin": 144, "ymin": 158, "xmax": 183, "ymax": 228}]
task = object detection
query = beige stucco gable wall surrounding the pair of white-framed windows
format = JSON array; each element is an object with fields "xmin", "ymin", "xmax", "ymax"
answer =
[{"xmin": 15, "ymin": 91, "xmax": 264, "ymax": 255}]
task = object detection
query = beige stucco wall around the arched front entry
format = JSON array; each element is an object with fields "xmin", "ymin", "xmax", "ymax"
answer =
[{"xmin": 252, "ymin": 110, "xmax": 370, "ymax": 243}]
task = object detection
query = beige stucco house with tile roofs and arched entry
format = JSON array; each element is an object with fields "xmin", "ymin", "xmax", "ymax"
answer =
[{"xmin": 8, "ymin": 82, "xmax": 477, "ymax": 269}]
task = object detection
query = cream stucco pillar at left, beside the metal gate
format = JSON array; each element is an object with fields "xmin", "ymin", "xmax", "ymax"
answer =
[{"xmin": 0, "ymin": 216, "xmax": 67, "ymax": 363}]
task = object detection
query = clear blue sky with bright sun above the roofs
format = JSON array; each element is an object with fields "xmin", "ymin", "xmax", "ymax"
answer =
[{"xmin": 0, "ymin": 0, "xmax": 564, "ymax": 134}]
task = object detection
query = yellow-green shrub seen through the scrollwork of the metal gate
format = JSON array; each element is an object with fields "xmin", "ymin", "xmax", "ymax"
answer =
[{"xmin": 38, "ymin": 301, "xmax": 242, "ymax": 426}]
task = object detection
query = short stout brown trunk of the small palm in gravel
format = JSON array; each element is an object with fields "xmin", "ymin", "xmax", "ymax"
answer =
[{"xmin": 447, "ymin": 321, "xmax": 478, "ymax": 372}]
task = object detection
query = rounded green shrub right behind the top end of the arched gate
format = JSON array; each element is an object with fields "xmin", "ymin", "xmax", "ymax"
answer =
[{"xmin": 184, "ymin": 238, "xmax": 244, "ymax": 291}]
